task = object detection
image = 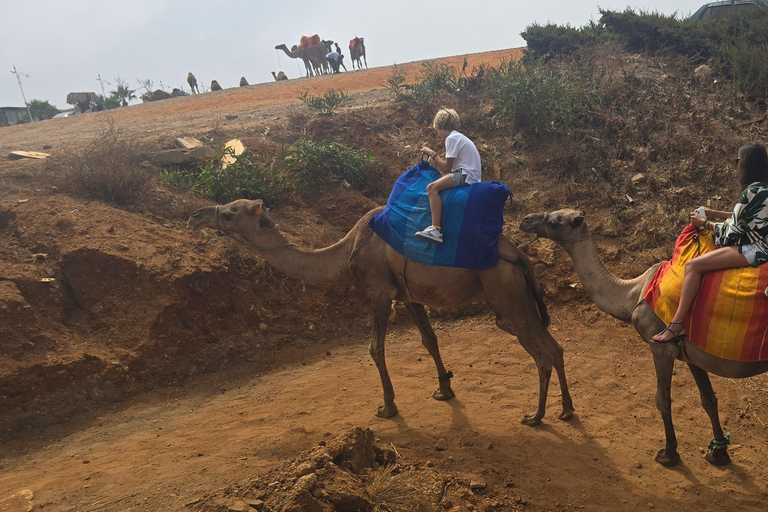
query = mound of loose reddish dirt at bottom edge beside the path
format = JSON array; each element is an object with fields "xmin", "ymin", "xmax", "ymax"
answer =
[{"xmin": 186, "ymin": 427, "xmax": 524, "ymax": 512}]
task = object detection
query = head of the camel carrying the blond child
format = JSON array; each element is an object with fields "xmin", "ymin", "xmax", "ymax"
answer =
[{"xmin": 187, "ymin": 199, "xmax": 275, "ymax": 235}]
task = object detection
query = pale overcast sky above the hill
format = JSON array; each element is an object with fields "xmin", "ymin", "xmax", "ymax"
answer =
[{"xmin": 0, "ymin": 0, "xmax": 705, "ymax": 109}]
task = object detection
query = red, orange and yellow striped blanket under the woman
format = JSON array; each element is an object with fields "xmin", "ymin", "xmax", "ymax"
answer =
[{"xmin": 643, "ymin": 224, "xmax": 768, "ymax": 362}]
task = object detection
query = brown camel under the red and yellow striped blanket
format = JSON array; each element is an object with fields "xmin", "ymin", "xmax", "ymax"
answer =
[{"xmin": 520, "ymin": 209, "xmax": 768, "ymax": 466}]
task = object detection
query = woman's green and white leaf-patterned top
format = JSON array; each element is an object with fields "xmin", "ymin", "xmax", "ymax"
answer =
[{"xmin": 712, "ymin": 182, "xmax": 768, "ymax": 267}]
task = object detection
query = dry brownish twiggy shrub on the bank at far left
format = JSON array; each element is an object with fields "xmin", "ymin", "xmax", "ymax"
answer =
[{"xmin": 51, "ymin": 124, "xmax": 152, "ymax": 206}]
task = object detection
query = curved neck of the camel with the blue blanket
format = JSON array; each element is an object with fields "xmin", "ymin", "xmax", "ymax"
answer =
[{"xmin": 243, "ymin": 230, "xmax": 355, "ymax": 284}]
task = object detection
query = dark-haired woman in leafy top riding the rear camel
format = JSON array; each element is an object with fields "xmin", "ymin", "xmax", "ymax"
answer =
[{"xmin": 651, "ymin": 142, "xmax": 768, "ymax": 343}]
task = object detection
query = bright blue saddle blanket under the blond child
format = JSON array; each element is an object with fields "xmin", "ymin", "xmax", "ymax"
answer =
[{"xmin": 368, "ymin": 162, "xmax": 510, "ymax": 269}]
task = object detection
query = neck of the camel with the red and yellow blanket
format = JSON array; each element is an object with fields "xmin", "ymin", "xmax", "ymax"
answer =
[{"xmin": 561, "ymin": 238, "xmax": 656, "ymax": 322}]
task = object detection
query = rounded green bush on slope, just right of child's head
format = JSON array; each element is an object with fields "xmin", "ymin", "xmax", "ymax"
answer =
[{"xmin": 489, "ymin": 62, "xmax": 596, "ymax": 134}]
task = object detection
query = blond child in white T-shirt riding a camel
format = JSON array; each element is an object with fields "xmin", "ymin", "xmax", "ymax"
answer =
[{"xmin": 416, "ymin": 108, "xmax": 482, "ymax": 244}]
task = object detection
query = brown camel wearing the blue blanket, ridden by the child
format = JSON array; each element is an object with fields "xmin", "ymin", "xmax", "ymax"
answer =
[{"xmin": 189, "ymin": 199, "xmax": 574, "ymax": 425}]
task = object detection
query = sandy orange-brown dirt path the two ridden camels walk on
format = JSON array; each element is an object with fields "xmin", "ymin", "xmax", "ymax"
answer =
[{"xmin": 0, "ymin": 308, "xmax": 768, "ymax": 511}]
